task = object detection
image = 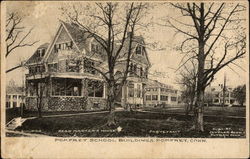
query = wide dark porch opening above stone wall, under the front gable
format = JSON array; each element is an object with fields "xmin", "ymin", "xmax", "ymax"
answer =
[{"xmin": 52, "ymin": 78, "xmax": 82, "ymax": 96}]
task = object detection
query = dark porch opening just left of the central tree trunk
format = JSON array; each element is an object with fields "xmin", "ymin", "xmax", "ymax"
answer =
[{"xmin": 88, "ymin": 80, "xmax": 104, "ymax": 97}]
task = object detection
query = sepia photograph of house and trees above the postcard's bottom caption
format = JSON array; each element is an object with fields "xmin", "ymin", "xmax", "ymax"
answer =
[{"xmin": 1, "ymin": 1, "xmax": 249, "ymax": 158}]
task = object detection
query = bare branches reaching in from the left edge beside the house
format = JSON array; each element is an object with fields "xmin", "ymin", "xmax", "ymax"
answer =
[{"xmin": 5, "ymin": 12, "xmax": 38, "ymax": 73}]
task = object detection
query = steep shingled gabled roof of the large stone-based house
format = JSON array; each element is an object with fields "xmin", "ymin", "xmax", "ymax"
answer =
[{"xmin": 27, "ymin": 21, "xmax": 151, "ymax": 65}]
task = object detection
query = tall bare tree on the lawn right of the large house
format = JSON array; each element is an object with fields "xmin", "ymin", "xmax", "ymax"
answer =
[{"xmin": 164, "ymin": 3, "xmax": 246, "ymax": 131}]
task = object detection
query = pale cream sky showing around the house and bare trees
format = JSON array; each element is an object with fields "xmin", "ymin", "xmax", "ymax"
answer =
[{"xmin": 6, "ymin": 1, "xmax": 247, "ymax": 88}]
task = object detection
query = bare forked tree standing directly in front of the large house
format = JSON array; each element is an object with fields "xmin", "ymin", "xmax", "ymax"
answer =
[{"xmin": 62, "ymin": 2, "xmax": 147, "ymax": 125}]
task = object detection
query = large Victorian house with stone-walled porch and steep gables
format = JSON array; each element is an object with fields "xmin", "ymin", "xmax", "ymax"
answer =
[{"xmin": 26, "ymin": 22, "xmax": 150, "ymax": 111}]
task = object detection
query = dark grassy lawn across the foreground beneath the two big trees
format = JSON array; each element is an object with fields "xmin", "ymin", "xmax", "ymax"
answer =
[{"xmin": 16, "ymin": 111, "xmax": 245, "ymax": 137}]
